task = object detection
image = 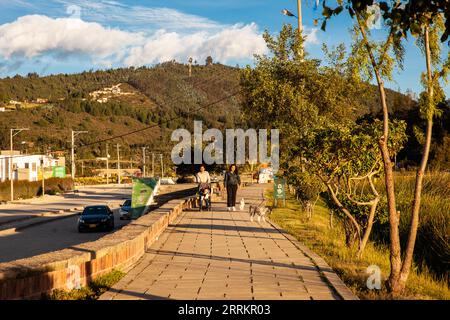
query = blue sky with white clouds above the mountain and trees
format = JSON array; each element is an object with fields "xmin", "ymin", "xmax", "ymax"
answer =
[{"xmin": 0, "ymin": 0, "xmax": 450, "ymax": 97}]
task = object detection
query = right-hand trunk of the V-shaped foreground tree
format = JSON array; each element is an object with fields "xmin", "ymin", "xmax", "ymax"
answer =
[{"xmin": 396, "ymin": 26, "xmax": 434, "ymax": 293}]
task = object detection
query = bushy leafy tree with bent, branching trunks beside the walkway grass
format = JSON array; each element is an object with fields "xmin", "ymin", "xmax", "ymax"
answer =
[{"xmin": 304, "ymin": 120, "xmax": 406, "ymax": 257}]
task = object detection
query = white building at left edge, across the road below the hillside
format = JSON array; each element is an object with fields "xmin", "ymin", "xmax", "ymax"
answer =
[{"xmin": 0, "ymin": 151, "xmax": 65, "ymax": 182}]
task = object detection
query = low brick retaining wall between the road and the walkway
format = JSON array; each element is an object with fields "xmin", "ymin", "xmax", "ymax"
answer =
[{"xmin": 0, "ymin": 198, "xmax": 195, "ymax": 300}]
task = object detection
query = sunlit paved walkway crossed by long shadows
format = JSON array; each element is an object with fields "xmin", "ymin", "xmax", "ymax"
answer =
[{"xmin": 101, "ymin": 185, "xmax": 352, "ymax": 300}]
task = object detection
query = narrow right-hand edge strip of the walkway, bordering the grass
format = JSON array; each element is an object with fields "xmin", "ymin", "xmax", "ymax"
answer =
[{"xmin": 266, "ymin": 219, "xmax": 359, "ymax": 300}]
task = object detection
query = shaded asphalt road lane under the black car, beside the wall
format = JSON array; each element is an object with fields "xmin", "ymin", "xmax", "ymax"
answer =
[{"xmin": 0, "ymin": 184, "xmax": 192, "ymax": 263}]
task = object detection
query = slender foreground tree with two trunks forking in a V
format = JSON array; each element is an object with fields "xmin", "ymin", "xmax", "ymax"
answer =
[{"xmin": 322, "ymin": 0, "xmax": 450, "ymax": 294}]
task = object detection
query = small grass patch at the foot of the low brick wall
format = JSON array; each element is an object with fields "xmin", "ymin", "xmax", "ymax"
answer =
[{"xmin": 49, "ymin": 270, "xmax": 125, "ymax": 300}]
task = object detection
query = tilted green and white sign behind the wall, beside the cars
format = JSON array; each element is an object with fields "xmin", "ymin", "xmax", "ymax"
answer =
[{"xmin": 131, "ymin": 178, "xmax": 158, "ymax": 219}]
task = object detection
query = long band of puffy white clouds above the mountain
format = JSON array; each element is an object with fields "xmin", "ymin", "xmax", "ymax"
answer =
[{"xmin": 0, "ymin": 15, "xmax": 266, "ymax": 66}]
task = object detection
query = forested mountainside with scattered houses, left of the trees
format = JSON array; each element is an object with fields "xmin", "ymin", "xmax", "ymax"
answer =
[{"xmin": 0, "ymin": 62, "xmax": 240, "ymax": 164}]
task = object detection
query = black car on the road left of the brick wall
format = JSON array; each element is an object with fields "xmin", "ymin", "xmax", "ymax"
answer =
[{"xmin": 78, "ymin": 206, "xmax": 114, "ymax": 232}]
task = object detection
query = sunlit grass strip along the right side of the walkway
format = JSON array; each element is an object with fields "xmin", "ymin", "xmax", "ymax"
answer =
[{"xmin": 267, "ymin": 193, "xmax": 450, "ymax": 300}]
